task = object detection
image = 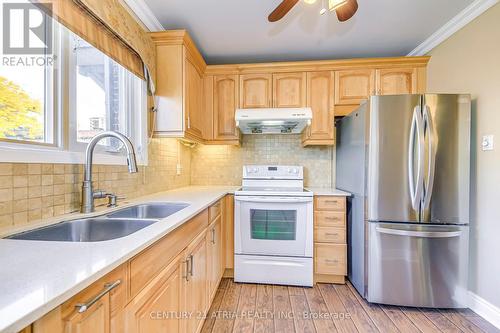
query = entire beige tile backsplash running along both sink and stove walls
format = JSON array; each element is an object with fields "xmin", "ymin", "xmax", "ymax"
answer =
[{"xmin": 0, "ymin": 135, "xmax": 335, "ymax": 233}]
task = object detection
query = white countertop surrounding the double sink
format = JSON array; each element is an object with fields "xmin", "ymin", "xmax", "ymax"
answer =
[{"xmin": 0, "ymin": 186, "xmax": 237, "ymax": 332}]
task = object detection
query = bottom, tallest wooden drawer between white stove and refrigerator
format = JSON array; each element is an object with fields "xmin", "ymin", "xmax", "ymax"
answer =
[{"xmin": 314, "ymin": 243, "xmax": 347, "ymax": 275}]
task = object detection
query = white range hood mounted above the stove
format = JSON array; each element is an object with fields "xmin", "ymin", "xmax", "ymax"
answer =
[{"xmin": 235, "ymin": 108, "xmax": 312, "ymax": 134}]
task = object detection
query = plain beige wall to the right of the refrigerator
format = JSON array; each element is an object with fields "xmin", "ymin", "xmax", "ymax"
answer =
[{"xmin": 427, "ymin": 4, "xmax": 500, "ymax": 307}]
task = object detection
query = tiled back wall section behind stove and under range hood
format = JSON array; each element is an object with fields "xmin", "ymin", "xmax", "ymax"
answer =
[{"xmin": 191, "ymin": 135, "xmax": 335, "ymax": 187}]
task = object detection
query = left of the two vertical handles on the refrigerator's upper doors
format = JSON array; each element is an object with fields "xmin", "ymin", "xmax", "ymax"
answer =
[{"xmin": 408, "ymin": 105, "xmax": 424, "ymax": 210}]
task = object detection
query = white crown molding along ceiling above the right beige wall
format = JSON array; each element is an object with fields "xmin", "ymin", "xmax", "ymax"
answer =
[{"xmin": 408, "ymin": 0, "xmax": 500, "ymax": 56}]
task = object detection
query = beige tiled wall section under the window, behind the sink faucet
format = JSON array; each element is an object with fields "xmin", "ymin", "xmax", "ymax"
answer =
[{"xmin": 0, "ymin": 139, "xmax": 191, "ymax": 233}]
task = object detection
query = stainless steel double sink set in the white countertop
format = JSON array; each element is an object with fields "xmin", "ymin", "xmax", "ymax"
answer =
[{"xmin": 7, "ymin": 202, "xmax": 189, "ymax": 242}]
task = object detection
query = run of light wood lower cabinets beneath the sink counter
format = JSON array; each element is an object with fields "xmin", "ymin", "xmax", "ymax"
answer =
[{"xmin": 28, "ymin": 198, "xmax": 226, "ymax": 333}]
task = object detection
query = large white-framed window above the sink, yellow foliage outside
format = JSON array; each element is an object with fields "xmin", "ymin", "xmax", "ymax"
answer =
[{"xmin": 0, "ymin": 12, "xmax": 147, "ymax": 163}]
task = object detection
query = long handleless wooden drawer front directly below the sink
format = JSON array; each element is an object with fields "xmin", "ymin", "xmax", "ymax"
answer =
[{"xmin": 129, "ymin": 209, "xmax": 208, "ymax": 298}]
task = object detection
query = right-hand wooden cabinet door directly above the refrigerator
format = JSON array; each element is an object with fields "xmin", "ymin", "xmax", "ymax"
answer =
[{"xmin": 377, "ymin": 68, "xmax": 417, "ymax": 95}]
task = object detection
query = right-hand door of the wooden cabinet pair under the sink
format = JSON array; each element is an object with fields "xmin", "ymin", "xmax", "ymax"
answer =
[{"xmin": 182, "ymin": 233, "xmax": 208, "ymax": 333}]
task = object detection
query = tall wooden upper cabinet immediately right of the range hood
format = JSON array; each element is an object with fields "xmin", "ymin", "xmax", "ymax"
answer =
[{"xmin": 302, "ymin": 71, "xmax": 335, "ymax": 146}]
